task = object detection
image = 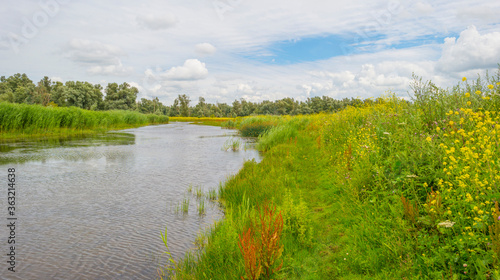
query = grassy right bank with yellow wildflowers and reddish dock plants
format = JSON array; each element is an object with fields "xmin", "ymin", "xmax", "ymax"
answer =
[{"xmin": 159, "ymin": 72, "xmax": 500, "ymax": 279}]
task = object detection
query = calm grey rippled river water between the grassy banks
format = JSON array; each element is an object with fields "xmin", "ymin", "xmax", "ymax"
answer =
[{"xmin": 0, "ymin": 123, "xmax": 259, "ymax": 279}]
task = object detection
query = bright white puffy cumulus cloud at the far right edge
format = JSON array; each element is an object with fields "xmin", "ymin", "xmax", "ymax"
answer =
[{"xmin": 437, "ymin": 26, "xmax": 500, "ymax": 73}]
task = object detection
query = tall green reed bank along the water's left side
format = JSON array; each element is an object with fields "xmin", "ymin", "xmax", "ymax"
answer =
[{"xmin": 0, "ymin": 102, "xmax": 169, "ymax": 140}]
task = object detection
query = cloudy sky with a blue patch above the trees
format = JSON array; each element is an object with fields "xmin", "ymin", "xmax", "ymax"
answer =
[{"xmin": 0, "ymin": 0, "xmax": 500, "ymax": 105}]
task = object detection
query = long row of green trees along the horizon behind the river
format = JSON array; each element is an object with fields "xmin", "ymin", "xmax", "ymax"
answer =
[{"xmin": 0, "ymin": 73, "xmax": 377, "ymax": 117}]
